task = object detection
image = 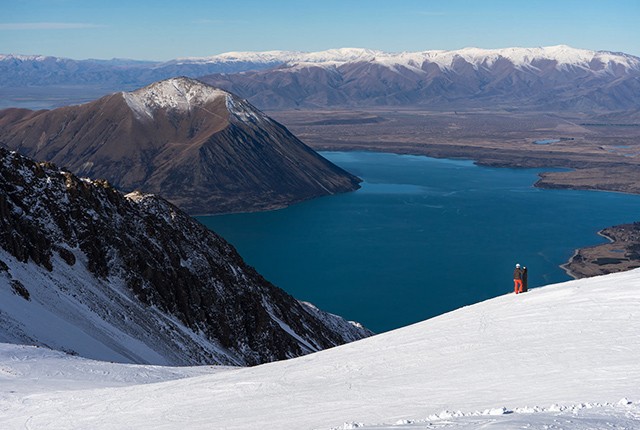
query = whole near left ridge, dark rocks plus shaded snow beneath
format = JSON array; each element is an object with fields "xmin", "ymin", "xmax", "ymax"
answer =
[{"xmin": 0, "ymin": 148, "xmax": 370, "ymax": 366}]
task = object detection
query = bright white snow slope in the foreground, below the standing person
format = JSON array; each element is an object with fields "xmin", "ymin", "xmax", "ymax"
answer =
[{"xmin": 0, "ymin": 270, "xmax": 640, "ymax": 430}]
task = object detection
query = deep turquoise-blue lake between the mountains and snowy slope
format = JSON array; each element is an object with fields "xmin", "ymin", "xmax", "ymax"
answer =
[{"xmin": 199, "ymin": 152, "xmax": 640, "ymax": 332}]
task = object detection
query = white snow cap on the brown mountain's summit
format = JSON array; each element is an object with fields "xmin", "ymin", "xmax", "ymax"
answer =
[{"xmin": 122, "ymin": 77, "xmax": 228, "ymax": 119}]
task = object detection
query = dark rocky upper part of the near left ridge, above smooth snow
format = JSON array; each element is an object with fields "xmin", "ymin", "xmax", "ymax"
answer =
[{"xmin": 0, "ymin": 148, "xmax": 370, "ymax": 364}]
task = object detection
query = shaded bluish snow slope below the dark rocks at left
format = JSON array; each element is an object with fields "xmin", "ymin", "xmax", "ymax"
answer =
[{"xmin": 0, "ymin": 248, "xmax": 242, "ymax": 365}]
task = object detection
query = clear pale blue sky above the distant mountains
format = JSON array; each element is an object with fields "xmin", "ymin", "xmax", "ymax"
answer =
[{"xmin": 0, "ymin": 0, "xmax": 640, "ymax": 60}]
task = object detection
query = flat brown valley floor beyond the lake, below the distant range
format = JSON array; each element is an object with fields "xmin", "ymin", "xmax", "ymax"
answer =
[{"xmin": 269, "ymin": 109, "xmax": 640, "ymax": 194}]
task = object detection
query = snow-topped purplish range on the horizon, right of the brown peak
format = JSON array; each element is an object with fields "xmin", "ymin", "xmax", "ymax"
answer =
[{"xmin": 202, "ymin": 46, "xmax": 640, "ymax": 112}]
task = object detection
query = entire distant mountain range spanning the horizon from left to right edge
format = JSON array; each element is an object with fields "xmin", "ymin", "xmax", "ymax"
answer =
[{"xmin": 0, "ymin": 45, "xmax": 640, "ymax": 112}]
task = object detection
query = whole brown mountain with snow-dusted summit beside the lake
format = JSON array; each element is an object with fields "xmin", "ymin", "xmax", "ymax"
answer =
[{"xmin": 0, "ymin": 78, "xmax": 359, "ymax": 213}]
